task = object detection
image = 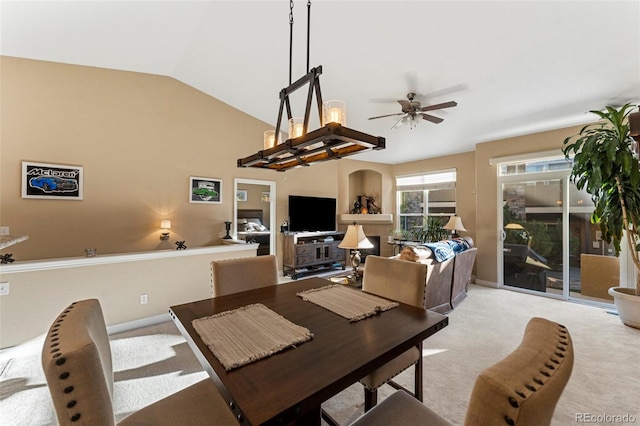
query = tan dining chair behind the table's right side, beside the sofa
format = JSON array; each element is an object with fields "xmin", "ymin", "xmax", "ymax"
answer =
[{"xmin": 360, "ymin": 255, "xmax": 426, "ymax": 411}]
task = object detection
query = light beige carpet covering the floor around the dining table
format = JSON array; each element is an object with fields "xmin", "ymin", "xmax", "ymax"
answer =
[{"xmin": 0, "ymin": 286, "xmax": 640, "ymax": 426}]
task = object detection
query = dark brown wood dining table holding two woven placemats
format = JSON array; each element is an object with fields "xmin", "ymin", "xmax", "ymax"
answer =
[{"xmin": 170, "ymin": 278, "xmax": 448, "ymax": 425}]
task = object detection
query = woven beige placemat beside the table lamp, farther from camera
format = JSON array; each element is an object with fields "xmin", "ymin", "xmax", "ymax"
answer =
[{"xmin": 298, "ymin": 284, "xmax": 399, "ymax": 322}]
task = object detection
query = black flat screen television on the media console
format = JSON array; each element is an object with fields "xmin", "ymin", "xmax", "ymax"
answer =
[{"xmin": 289, "ymin": 195, "xmax": 336, "ymax": 232}]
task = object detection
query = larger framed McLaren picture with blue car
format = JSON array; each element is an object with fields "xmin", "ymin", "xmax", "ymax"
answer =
[{"xmin": 22, "ymin": 161, "xmax": 84, "ymax": 200}]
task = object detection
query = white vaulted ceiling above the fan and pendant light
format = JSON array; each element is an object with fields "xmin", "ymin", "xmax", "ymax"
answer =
[{"xmin": 0, "ymin": 0, "xmax": 640, "ymax": 163}]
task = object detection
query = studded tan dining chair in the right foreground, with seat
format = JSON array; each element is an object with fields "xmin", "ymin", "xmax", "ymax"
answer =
[{"xmin": 352, "ymin": 316, "xmax": 574, "ymax": 426}]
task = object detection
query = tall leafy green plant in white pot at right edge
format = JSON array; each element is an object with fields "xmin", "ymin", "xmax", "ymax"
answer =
[{"xmin": 562, "ymin": 104, "xmax": 640, "ymax": 328}]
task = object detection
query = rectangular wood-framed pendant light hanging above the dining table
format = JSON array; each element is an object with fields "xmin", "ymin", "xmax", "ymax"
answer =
[{"xmin": 238, "ymin": 0, "xmax": 385, "ymax": 172}]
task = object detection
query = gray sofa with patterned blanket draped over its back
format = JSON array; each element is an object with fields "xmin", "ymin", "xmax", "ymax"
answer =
[{"xmin": 394, "ymin": 243, "xmax": 478, "ymax": 313}]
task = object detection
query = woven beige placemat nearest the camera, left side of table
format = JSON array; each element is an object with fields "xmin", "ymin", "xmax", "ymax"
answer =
[{"xmin": 191, "ymin": 303, "xmax": 313, "ymax": 371}]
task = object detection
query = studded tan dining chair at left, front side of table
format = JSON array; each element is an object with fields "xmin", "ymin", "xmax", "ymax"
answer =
[{"xmin": 42, "ymin": 299, "xmax": 238, "ymax": 426}]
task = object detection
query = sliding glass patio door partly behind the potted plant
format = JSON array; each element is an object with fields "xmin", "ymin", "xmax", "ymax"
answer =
[{"xmin": 498, "ymin": 158, "xmax": 619, "ymax": 303}]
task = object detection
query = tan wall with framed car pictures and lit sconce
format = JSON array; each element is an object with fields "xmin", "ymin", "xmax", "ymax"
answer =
[{"xmin": 0, "ymin": 57, "xmax": 338, "ymax": 260}]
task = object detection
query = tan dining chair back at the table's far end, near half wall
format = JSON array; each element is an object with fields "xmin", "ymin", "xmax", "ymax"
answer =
[{"xmin": 211, "ymin": 255, "xmax": 278, "ymax": 297}]
